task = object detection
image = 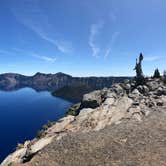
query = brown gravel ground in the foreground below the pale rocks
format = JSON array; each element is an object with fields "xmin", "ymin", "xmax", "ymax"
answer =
[{"xmin": 15, "ymin": 108, "xmax": 166, "ymax": 166}]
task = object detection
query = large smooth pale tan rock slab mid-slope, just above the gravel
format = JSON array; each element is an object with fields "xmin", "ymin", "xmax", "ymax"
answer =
[{"xmin": 75, "ymin": 96, "xmax": 133, "ymax": 131}]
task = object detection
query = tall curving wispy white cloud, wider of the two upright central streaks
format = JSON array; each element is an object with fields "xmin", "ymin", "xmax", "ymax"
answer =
[{"xmin": 88, "ymin": 21, "xmax": 104, "ymax": 57}]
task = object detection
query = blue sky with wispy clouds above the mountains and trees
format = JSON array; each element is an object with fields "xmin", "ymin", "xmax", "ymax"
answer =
[{"xmin": 0, "ymin": 0, "xmax": 166, "ymax": 76}]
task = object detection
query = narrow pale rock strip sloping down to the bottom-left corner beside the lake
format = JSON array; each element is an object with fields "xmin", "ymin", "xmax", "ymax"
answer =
[{"xmin": 1, "ymin": 115, "xmax": 74, "ymax": 166}]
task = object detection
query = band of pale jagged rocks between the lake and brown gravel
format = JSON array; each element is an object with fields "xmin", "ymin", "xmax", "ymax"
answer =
[{"xmin": 1, "ymin": 78, "xmax": 166, "ymax": 166}]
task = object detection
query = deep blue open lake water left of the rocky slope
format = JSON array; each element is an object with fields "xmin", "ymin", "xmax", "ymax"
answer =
[{"xmin": 0, "ymin": 88, "xmax": 72, "ymax": 162}]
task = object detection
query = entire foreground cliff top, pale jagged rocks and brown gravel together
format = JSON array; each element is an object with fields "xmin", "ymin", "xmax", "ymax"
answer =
[{"xmin": 1, "ymin": 78, "xmax": 166, "ymax": 166}]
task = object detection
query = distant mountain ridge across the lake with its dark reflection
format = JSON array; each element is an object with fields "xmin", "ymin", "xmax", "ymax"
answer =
[{"xmin": 0, "ymin": 72, "xmax": 131, "ymax": 92}]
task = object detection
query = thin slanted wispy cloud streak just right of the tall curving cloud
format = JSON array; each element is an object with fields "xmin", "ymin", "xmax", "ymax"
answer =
[{"xmin": 104, "ymin": 32, "xmax": 120, "ymax": 58}]
